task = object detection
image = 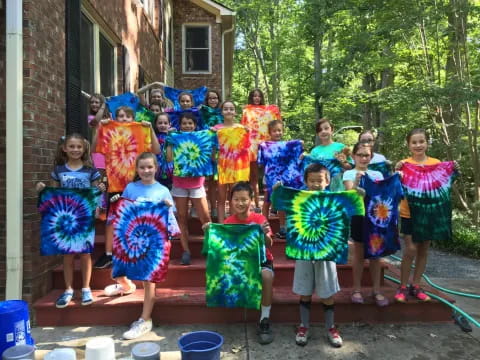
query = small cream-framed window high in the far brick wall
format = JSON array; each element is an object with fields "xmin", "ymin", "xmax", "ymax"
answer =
[{"xmin": 183, "ymin": 25, "xmax": 211, "ymax": 73}]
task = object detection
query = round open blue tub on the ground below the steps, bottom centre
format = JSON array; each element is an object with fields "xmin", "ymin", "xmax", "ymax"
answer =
[{"xmin": 178, "ymin": 331, "xmax": 223, "ymax": 360}]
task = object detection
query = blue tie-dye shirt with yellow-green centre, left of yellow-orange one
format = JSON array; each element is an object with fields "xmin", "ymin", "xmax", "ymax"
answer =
[{"xmin": 167, "ymin": 130, "xmax": 217, "ymax": 177}]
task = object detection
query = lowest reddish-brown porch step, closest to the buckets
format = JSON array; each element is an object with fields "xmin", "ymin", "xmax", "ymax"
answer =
[{"xmin": 34, "ymin": 281, "xmax": 451, "ymax": 326}]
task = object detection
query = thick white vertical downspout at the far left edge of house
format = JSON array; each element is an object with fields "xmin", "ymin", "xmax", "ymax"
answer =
[{"xmin": 5, "ymin": 0, "xmax": 23, "ymax": 299}]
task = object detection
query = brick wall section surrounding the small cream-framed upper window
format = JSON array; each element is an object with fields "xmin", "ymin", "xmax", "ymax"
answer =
[{"xmin": 173, "ymin": 0, "xmax": 222, "ymax": 97}]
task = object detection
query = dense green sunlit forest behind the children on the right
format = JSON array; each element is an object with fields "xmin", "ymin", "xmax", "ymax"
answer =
[{"xmin": 222, "ymin": 0, "xmax": 480, "ymax": 257}]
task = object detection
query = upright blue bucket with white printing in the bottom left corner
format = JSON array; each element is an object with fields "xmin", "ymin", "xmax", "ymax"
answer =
[{"xmin": 0, "ymin": 300, "xmax": 35, "ymax": 354}]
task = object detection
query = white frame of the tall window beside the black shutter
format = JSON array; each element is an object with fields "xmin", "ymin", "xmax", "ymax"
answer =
[{"xmin": 81, "ymin": 5, "xmax": 118, "ymax": 96}]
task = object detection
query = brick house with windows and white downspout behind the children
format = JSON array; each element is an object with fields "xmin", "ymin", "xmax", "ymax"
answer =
[{"xmin": 0, "ymin": 0, "xmax": 234, "ymax": 302}]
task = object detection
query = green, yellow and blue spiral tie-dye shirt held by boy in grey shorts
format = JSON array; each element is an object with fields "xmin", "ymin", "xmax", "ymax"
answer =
[{"xmin": 272, "ymin": 186, "xmax": 365, "ymax": 264}]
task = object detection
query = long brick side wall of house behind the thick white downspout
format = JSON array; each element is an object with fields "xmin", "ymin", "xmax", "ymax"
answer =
[{"xmin": 0, "ymin": 0, "xmax": 163, "ymax": 301}]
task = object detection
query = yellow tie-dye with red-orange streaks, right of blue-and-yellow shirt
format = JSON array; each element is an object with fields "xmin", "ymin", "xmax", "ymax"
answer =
[{"xmin": 217, "ymin": 126, "xmax": 250, "ymax": 184}]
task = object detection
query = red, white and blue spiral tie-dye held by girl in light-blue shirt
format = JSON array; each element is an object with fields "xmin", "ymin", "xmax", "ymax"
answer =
[{"xmin": 111, "ymin": 198, "xmax": 179, "ymax": 283}]
